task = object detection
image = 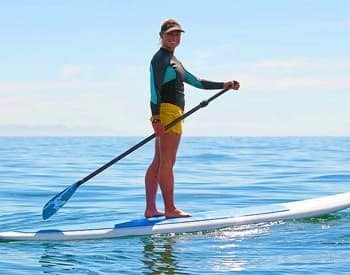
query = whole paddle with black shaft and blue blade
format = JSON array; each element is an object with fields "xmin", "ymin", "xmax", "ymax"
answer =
[{"xmin": 42, "ymin": 89, "xmax": 229, "ymax": 220}]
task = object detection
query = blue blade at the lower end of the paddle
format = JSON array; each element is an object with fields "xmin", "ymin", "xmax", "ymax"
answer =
[{"xmin": 42, "ymin": 183, "xmax": 79, "ymax": 220}]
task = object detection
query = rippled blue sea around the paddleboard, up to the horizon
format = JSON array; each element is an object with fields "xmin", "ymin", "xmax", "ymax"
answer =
[{"xmin": 0, "ymin": 137, "xmax": 350, "ymax": 274}]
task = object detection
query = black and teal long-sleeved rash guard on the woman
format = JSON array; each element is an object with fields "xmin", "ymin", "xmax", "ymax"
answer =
[{"xmin": 150, "ymin": 48, "xmax": 224, "ymax": 115}]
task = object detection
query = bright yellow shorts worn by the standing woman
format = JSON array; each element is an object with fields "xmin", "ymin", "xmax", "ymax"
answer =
[{"xmin": 159, "ymin": 103, "xmax": 183, "ymax": 135}]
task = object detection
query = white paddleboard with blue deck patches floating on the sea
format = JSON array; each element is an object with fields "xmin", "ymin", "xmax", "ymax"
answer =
[{"xmin": 0, "ymin": 192, "xmax": 350, "ymax": 241}]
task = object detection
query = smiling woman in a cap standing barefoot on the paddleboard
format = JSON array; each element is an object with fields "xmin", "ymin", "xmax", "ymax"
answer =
[{"xmin": 145, "ymin": 19, "xmax": 239, "ymax": 218}]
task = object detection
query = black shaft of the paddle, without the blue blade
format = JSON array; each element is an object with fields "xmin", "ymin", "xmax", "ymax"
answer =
[{"xmin": 77, "ymin": 89, "xmax": 229, "ymax": 186}]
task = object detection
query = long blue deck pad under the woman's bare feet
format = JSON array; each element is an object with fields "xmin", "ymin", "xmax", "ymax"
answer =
[{"xmin": 114, "ymin": 205, "xmax": 289, "ymax": 228}]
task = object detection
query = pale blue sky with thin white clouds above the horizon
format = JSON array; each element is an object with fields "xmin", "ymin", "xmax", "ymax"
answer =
[{"xmin": 0, "ymin": 0, "xmax": 350, "ymax": 136}]
